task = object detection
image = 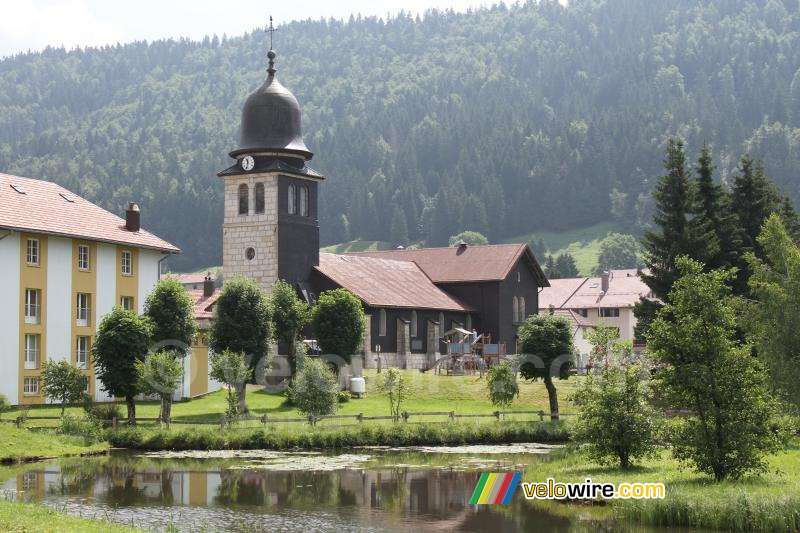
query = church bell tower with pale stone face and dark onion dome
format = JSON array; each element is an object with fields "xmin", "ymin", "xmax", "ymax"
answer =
[{"xmin": 217, "ymin": 34, "xmax": 323, "ymax": 299}]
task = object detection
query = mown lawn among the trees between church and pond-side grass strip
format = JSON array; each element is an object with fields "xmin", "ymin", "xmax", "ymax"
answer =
[{"xmin": 5, "ymin": 370, "xmax": 576, "ymax": 425}]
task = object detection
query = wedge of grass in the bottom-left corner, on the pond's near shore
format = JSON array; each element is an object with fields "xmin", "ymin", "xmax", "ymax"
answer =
[{"xmin": 0, "ymin": 501, "xmax": 142, "ymax": 533}]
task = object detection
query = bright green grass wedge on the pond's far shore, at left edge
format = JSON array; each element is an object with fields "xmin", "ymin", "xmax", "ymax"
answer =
[{"xmin": 0, "ymin": 422, "xmax": 108, "ymax": 463}]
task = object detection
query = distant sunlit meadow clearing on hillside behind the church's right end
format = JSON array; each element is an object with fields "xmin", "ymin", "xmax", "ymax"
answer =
[{"xmin": 504, "ymin": 222, "xmax": 616, "ymax": 276}]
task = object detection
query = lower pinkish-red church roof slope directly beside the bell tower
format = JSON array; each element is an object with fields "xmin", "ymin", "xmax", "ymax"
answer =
[{"xmin": 315, "ymin": 253, "xmax": 473, "ymax": 311}]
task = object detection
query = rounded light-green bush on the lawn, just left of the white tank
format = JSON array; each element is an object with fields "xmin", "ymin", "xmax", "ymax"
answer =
[{"xmin": 289, "ymin": 357, "xmax": 339, "ymax": 415}]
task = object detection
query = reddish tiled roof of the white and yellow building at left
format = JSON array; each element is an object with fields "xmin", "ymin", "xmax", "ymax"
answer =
[{"xmin": 0, "ymin": 173, "xmax": 180, "ymax": 253}]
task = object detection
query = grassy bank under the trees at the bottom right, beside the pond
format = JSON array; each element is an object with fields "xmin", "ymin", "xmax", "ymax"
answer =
[{"xmin": 526, "ymin": 442, "xmax": 800, "ymax": 532}]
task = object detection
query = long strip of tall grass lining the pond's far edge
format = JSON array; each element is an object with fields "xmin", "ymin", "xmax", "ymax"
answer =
[{"xmin": 108, "ymin": 421, "xmax": 569, "ymax": 450}]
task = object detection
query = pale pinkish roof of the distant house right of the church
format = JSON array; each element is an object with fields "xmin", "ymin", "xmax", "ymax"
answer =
[{"xmin": 539, "ymin": 269, "xmax": 650, "ymax": 309}]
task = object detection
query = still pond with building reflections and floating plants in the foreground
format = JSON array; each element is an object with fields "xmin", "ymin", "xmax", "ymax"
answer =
[{"xmin": 0, "ymin": 445, "xmax": 656, "ymax": 533}]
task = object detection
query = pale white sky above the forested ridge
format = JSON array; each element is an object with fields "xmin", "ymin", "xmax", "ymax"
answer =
[{"xmin": 0, "ymin": 0, "xmax": 492, "ymax": 57}]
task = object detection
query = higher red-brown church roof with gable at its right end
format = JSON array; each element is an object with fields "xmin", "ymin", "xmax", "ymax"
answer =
[{"xmin": 348, "ymin": 244, "xmax": 547, "ymax": 287}]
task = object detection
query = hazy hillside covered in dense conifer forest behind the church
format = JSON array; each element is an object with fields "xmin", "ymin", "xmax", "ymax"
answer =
[{"xmin": 0, "ymin": 0, "xmax": 800, "ymax": 269}]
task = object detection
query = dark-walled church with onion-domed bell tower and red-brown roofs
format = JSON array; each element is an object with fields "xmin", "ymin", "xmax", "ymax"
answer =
[{"xmin": 209, "ymin": 43, "xmax": 549, "ymax": 369}]
